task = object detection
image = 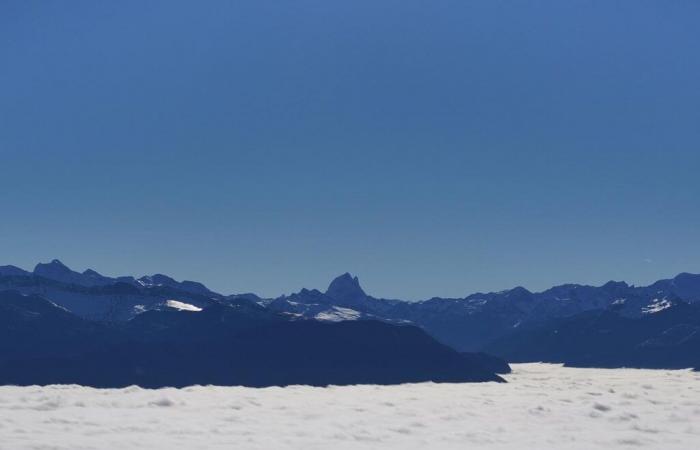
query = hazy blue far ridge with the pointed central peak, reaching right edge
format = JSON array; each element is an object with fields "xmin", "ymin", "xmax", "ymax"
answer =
[{"xmin": 261, "ymin": 273, "xmax": 700, "ymax": 351}]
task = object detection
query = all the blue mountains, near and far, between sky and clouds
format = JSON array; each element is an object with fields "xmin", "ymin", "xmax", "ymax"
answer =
[{"xmin": 0, "ymin": 260, "xmax": 700, "ymax": 386}]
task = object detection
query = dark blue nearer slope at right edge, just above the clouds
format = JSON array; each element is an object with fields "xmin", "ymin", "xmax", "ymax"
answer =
[{"xmin": 485, "ymin": 300, "xmax": 700, "ymax": 369}]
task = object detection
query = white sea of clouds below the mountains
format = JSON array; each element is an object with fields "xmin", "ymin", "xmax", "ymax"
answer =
[{"xmin": 0, "ymin": 364, "xmax": 700, "ymax": 450}]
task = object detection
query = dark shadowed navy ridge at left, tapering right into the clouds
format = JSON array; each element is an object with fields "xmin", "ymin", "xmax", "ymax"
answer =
[{"xmin": 0, "ymin": 291, "xmax": 503, "ymax": 388}]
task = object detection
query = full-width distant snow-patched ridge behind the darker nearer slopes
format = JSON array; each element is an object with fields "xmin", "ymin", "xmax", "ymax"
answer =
[{"xmin": 0, "ymin": 260, "xmax": 700, "ymax": 351}]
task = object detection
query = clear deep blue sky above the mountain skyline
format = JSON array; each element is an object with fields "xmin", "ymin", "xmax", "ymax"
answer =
[{"xmin": 0, "ymin": 0, "xmax": 700, "ymax": 299}]
